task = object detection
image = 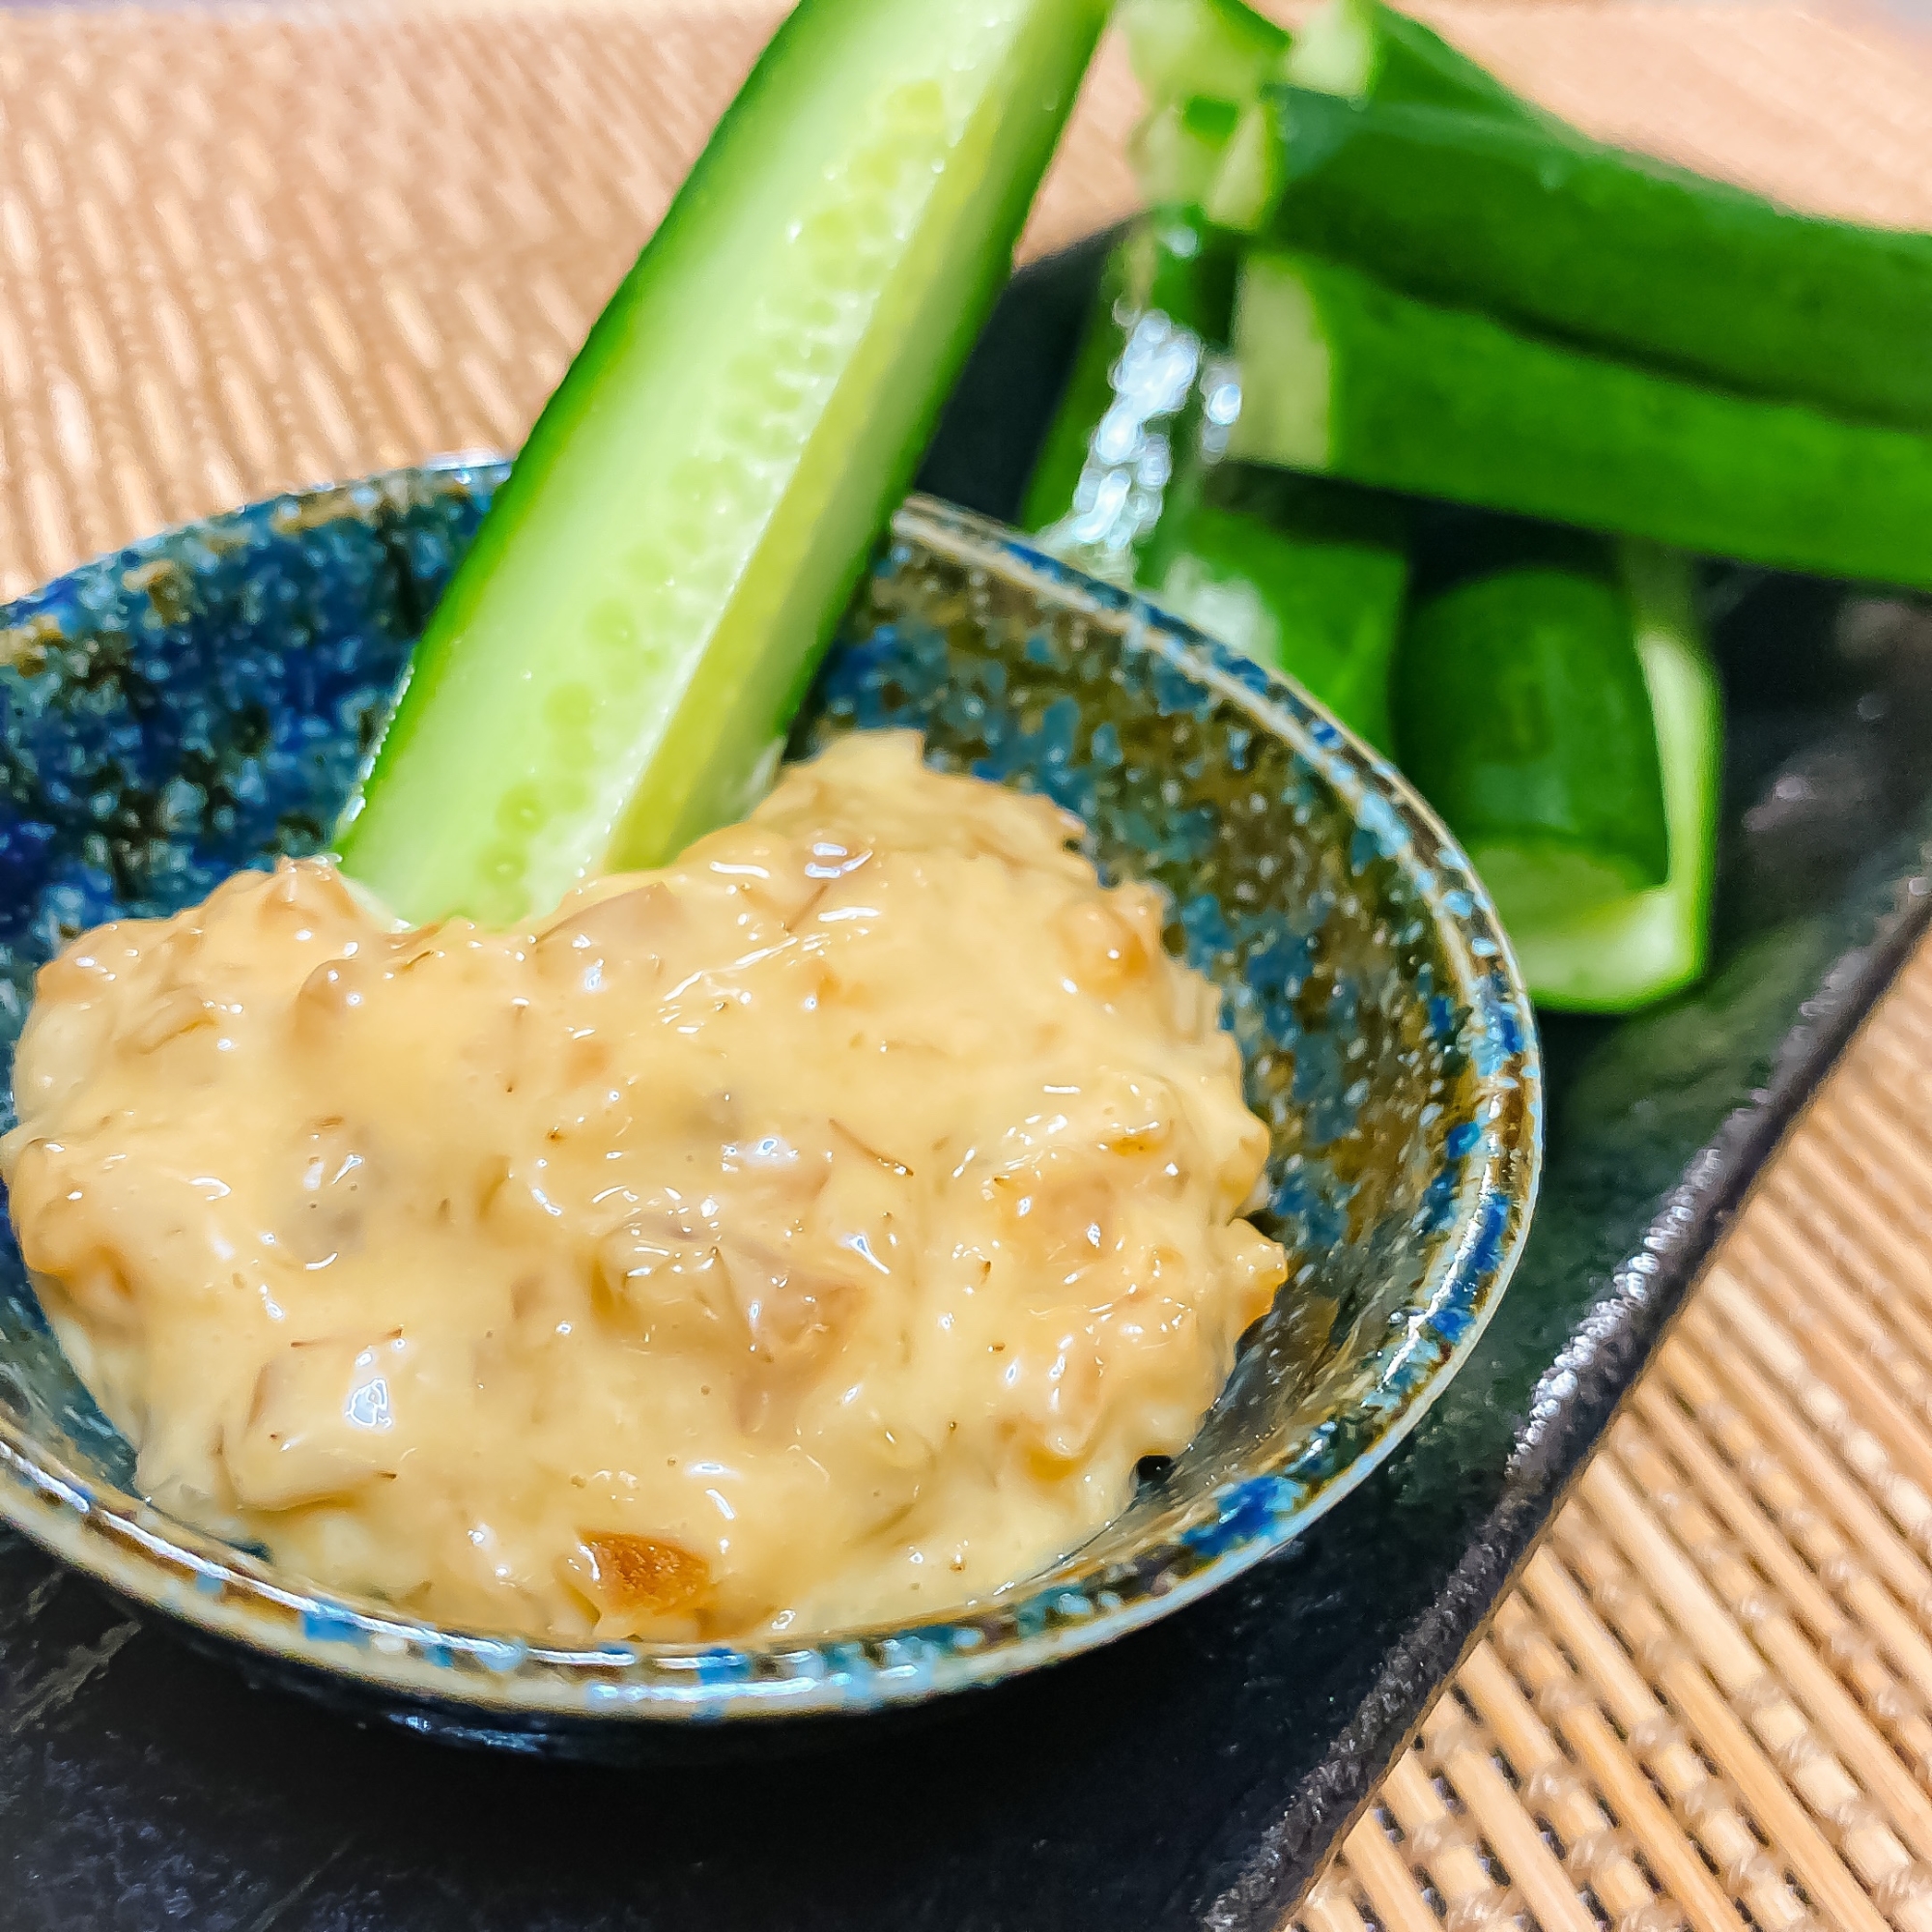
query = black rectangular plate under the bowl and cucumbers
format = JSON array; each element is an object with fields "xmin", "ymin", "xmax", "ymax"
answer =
[{"xmin": 11, "ymin": 247, "xmax": 1932, "ymax": 1932}]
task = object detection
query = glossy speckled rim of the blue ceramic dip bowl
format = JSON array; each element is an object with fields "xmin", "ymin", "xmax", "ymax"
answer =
[{"xmin": 0, "ymin": 452, "xmax": 1542, "ymax": 1743}]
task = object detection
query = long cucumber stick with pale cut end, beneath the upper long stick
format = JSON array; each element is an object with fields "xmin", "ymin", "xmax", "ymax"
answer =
[{"xmin": 1231, "ymin": 251, "xmax": 1932, "ymax": 589}]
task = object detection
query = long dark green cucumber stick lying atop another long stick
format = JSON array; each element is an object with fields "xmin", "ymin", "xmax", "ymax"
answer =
[{"xmin": 1269, "ymin": 89, "xmax": 1932, "ymax": 429}]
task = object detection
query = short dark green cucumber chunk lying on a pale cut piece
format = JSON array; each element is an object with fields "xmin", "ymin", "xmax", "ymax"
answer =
[{"xmin": 1395, "ymin": 529, "xmax": 1669, "ymax": 893}]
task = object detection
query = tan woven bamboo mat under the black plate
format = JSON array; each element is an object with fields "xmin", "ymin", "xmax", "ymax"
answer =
[{"xmin": 11, "ymin": 0, "xmax": 1932, "ymax": 1932}]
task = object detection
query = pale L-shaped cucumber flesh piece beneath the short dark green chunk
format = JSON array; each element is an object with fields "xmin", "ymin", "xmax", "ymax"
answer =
[{"xmin": 1507, "ymin": 543, "xmax": 1723, "ymax": 1012}]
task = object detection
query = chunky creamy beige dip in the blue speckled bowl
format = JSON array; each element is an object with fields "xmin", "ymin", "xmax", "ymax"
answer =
[{"xmin": 0, "ymin": 734, "xmax": 1283, "ymax": 1640}]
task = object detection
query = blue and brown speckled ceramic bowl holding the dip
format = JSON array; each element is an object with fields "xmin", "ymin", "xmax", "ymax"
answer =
[{"xmin": 0, "ymin": 464, "xmax": 1540, "ymax": 1756}]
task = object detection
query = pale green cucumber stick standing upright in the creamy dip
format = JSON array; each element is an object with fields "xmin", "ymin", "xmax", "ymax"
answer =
[{"xmin": 340, "ymin": 0, "xmax": 1107, "ymax": 922}]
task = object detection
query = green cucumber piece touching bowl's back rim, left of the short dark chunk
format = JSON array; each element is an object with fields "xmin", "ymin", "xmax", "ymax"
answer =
[{"xmin": 1144, "ymin": 464, "xmax": 1408, "ymax": 752}]
